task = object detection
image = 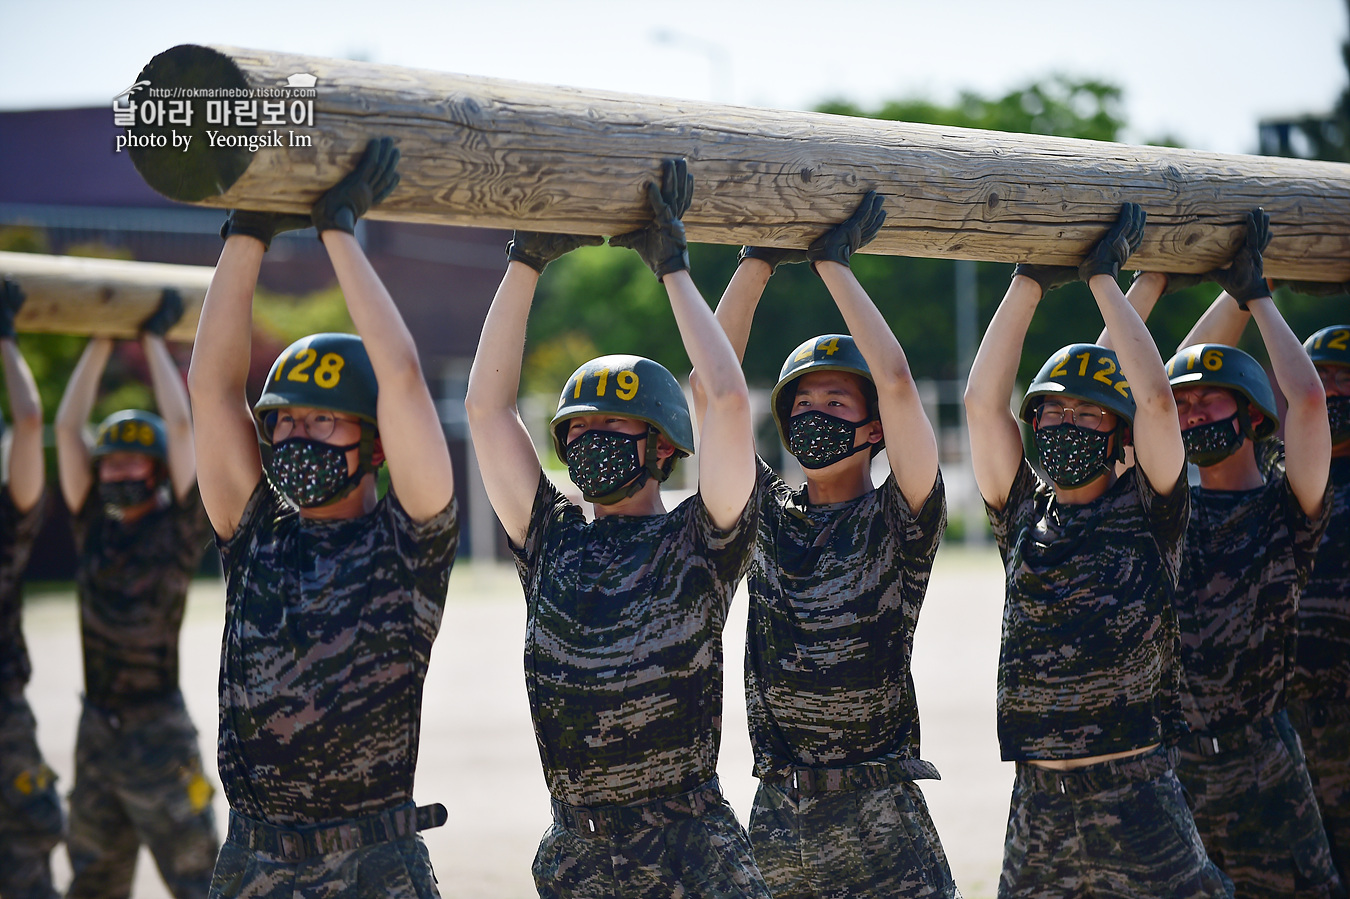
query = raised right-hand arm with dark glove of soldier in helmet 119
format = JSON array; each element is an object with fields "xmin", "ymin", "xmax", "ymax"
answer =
[{"xmin": 610, "ymin": 159, "xmax": 755, "ymax": 528}]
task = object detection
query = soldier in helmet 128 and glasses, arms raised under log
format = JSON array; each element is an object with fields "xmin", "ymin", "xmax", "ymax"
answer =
[{"xmin": 188, "ymin": 138, "xmax": 459, "ymax": 899}]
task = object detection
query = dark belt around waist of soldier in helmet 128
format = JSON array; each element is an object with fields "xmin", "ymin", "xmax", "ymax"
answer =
[{"xmin": 228, "ymin": 802, "xmax": 450, "ymax": 861}]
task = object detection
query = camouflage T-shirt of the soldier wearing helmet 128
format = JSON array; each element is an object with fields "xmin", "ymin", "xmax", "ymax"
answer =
[{"xmin": 216, "ymin": 478, "xmax": 459, "ymax": 825}]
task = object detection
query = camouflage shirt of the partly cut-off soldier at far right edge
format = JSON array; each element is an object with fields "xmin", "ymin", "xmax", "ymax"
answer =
[{"xmin": 1289, "ymin": 458, "xmax": 1350, "ymax": 705}]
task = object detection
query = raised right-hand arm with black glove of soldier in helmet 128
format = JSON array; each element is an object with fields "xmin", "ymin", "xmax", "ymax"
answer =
[{"xmin": 312, "ymin": 138, "xmax": 455, "ymax": 521}]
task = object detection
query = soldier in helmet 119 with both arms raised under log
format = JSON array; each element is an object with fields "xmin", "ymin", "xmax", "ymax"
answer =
[{"xmin": 466, "ymin": 159, "xmax": 768, "ymax": 899}]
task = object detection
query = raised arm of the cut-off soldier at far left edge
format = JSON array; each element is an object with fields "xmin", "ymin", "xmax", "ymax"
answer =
[{"xmin": 0, "ymin": 281, "xmax": 47, "ymax": 512}]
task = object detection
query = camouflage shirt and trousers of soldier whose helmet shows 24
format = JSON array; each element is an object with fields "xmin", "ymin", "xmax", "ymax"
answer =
[{"xmin": 745, "ymin": 460, "xmax": 959, "ymax": 899}]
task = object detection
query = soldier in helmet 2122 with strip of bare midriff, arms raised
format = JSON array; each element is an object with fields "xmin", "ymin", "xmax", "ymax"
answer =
[{"xmin": 965, "ymin": 204, "xmax": 1231, "ymax": 898}]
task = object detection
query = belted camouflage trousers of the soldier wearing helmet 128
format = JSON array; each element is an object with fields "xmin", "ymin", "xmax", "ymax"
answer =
[{"xmin": 211, "ymin": 803, "xmax": 444, "ymax": 899}]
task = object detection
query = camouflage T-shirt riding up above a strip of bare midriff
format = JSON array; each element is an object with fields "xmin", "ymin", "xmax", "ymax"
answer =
[{"xmin": 988, "ymin": 459, "xmax": 1191, "ymax": 761}]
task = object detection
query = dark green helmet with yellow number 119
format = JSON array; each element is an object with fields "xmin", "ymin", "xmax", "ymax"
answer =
[{"xmin": 549, "ymin": 355, "xmax": 694, "ymax": 469}]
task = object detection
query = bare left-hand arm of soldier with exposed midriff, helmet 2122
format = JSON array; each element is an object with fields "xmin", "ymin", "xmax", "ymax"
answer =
[{"xmin": 965, "ymin": 271, "xmax": 1044, "ymax": 510}]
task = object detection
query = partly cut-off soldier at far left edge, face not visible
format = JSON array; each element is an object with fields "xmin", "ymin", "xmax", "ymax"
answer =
[{"xmin": 0, "ymin": 281, "xmax": 62, "ymax": 899}]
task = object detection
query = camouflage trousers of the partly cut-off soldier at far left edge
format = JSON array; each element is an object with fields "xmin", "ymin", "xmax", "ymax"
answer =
[{"xmin": 0, "ymin": 691, "xmax": 63, "ymax": 899}]
